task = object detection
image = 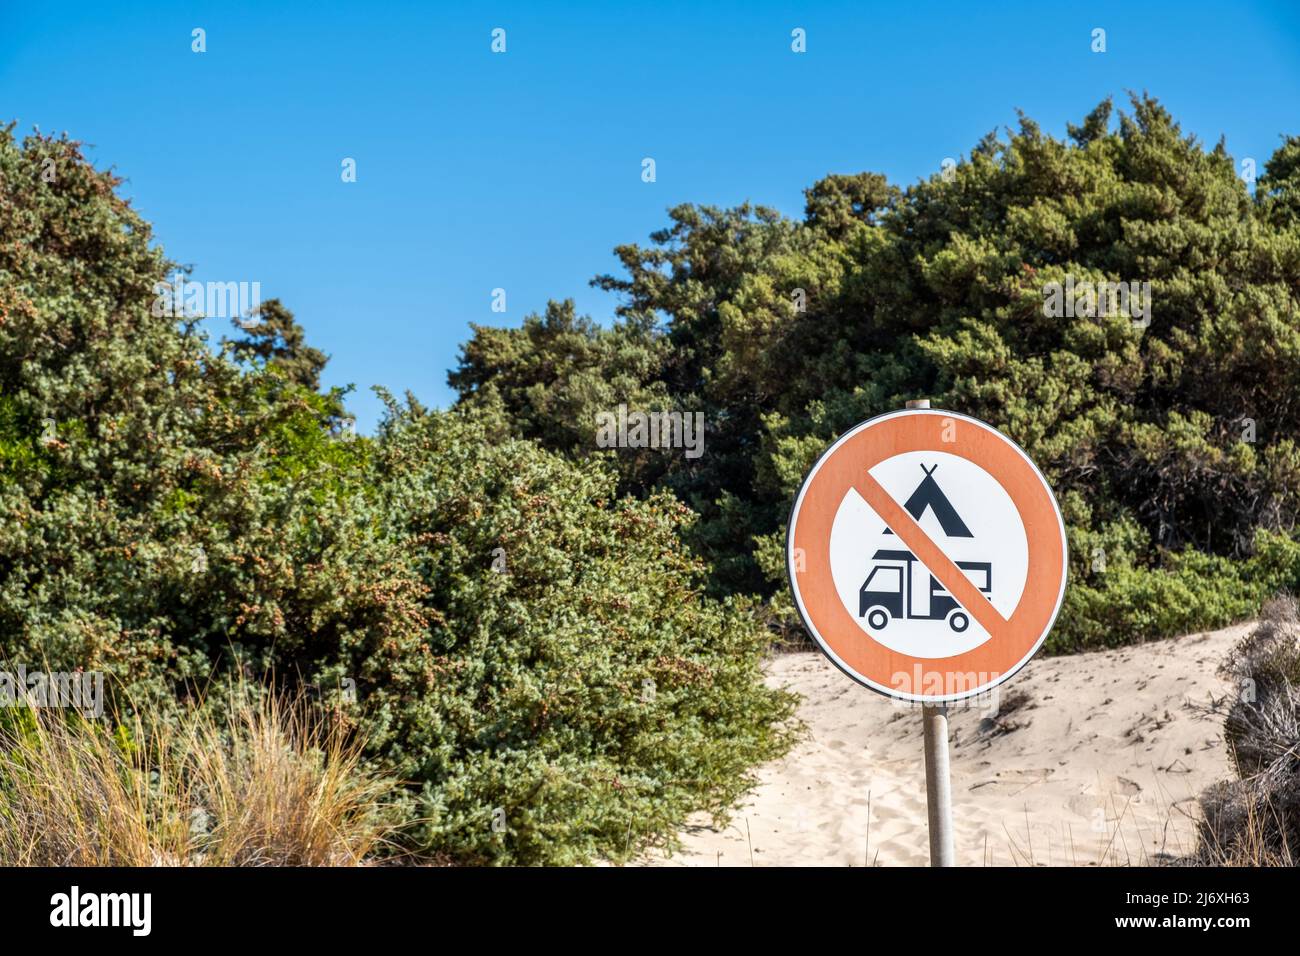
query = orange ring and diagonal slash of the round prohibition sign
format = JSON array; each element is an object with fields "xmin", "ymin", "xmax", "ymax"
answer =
[{"xmin": 785, "ymin": 408, "xmax": 1069, "ymax": 704}]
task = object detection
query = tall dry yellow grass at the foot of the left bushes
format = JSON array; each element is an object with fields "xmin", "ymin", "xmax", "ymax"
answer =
[{"xmin": 0, "ymin": 693, "xmax": 395, "ymax": 866}]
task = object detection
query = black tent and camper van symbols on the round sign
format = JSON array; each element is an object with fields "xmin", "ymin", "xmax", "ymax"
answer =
[{"xmin": 858, "ymin": 464, "xmax": 993, "ymax": 633}]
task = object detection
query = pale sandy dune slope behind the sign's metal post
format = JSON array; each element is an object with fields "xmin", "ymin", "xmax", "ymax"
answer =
[{"xmin": 646, "ymin": 626, "xmax": 1249, "ymax": 866}]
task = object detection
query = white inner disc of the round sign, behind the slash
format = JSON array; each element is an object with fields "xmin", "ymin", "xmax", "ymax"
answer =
[{"xmin": 831, "ymin": 451, "xmax": 1030, "ymax": 657}]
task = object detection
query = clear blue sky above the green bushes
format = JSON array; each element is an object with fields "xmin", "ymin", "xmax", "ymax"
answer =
[{"xmin": 0, "ymin": 0, "xmax": 1300, "ymax": 431}]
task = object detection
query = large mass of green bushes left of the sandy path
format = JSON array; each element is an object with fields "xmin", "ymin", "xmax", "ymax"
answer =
[{"xmin": 0, "ymin": 127, "xmax": 790, "ymax": 864}]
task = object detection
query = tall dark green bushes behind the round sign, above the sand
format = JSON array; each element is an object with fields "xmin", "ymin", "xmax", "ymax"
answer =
[{"xmin": 451, "ymin": 96, "xmax": 1300, "ymax": 649}]
